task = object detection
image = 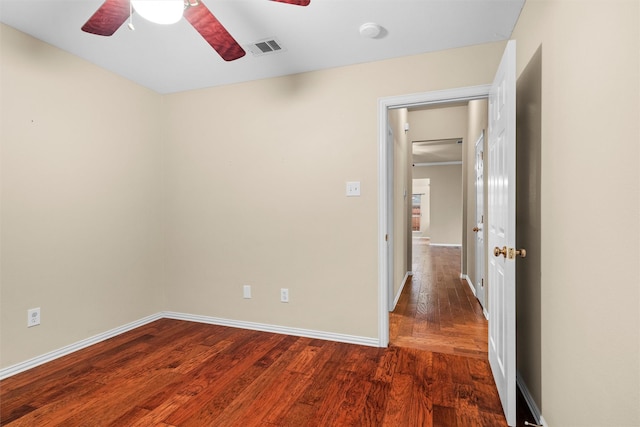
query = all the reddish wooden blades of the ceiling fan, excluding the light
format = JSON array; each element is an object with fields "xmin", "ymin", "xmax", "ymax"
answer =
[{"xmin": 82, "ymin": 0, "xmax": 311, "ymax": 61}]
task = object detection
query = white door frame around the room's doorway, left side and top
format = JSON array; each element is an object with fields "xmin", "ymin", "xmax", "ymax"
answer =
[{"xmin": 378, "ymin": 85, "xmax": 491, "ymax": 347}]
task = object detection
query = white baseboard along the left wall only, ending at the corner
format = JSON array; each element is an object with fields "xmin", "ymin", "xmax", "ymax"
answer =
[{"xmin": 0, "ymin": 313, "xmax": 162, "ymax": 380}]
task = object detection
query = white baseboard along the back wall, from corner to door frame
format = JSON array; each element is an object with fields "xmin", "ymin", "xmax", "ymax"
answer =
[{"xmin": 162, "ymin": 311, "xmax": 378, "ymax": 347}]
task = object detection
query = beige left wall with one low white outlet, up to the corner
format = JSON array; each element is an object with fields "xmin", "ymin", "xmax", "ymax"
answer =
[{"xmin": 0, "ymin": 25, "xmax": 164, "ymax": 367}]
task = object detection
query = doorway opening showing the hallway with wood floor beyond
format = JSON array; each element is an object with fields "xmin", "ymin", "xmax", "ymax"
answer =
[{"xmin": 390, "ymin": 99, "xmax": 488, "ymax": 359}]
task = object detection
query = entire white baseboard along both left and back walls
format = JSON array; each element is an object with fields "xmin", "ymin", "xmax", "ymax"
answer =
[{"xmin": 0, "ymin": 311, "xmax": 379, "ymax": 380}]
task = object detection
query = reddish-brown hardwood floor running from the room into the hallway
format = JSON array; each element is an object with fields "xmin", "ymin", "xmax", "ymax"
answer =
[{"xmin": 0, "ymin": 239, "xmax": 536, "ymax": 427}]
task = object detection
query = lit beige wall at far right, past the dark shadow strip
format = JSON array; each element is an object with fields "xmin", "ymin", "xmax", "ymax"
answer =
[{"xmin": 513, "ymin": 0, "xmax": 640, "ymax": 427}]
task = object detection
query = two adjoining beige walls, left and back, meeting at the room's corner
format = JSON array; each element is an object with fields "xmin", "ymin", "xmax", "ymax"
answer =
[{"xmin": 0, "ymin": 25, "xmax": 504, "ymax": 366}]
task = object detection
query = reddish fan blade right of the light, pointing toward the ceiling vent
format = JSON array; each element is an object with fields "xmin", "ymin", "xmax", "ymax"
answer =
[{"xmin": 184, "ymin": 1, "xmax": 245, "ymax": 61}]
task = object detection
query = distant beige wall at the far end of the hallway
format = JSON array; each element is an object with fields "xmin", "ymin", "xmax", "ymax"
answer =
[{"xmin": 413, "ymin": 165, "xmax": 462, "ymax": 245}]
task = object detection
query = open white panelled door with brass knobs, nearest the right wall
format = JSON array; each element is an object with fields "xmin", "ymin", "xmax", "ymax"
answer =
[{"xmin": 487, "ymin": 41, "xmax": 516, "ymax": 426}]
